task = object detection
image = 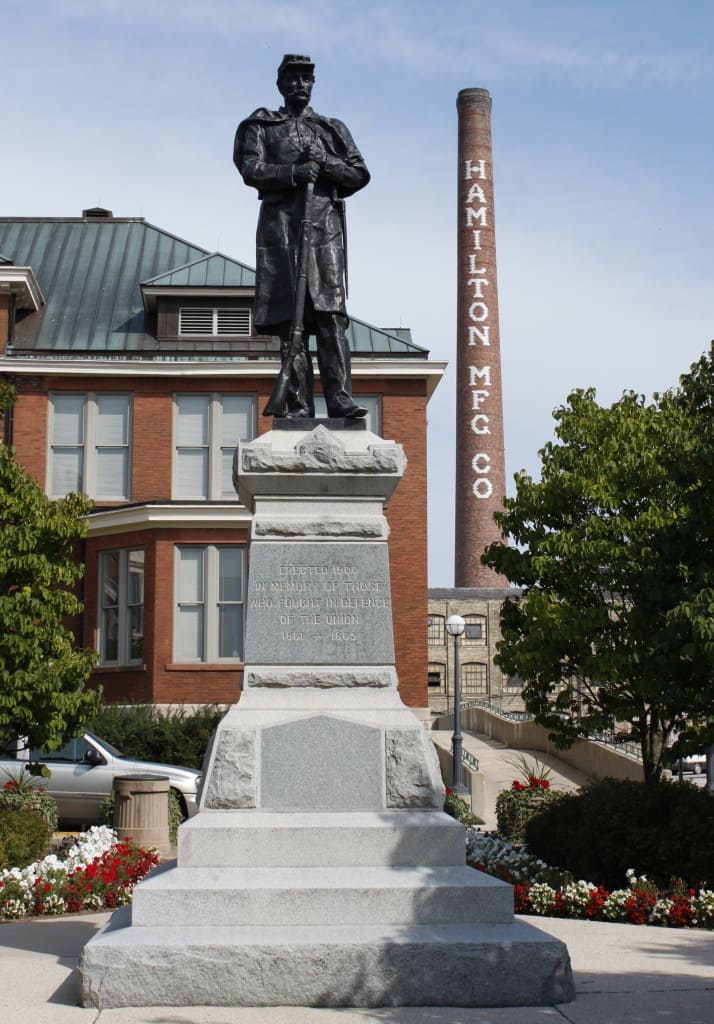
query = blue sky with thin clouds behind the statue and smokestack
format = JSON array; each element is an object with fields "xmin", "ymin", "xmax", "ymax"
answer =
[{"xmin": 5, "ymin": 0, "xmax": 714, "ymax": 586}]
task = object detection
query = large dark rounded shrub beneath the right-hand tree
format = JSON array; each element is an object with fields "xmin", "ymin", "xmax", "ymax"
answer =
[{"xmin": 526, "ymin": 779, "xmax": 714, "ymax": 889}]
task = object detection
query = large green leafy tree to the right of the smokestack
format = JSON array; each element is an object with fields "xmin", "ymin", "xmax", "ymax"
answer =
[{"xmin": 482, "ymin": 352, "xmax": 714, "ymax": 782}]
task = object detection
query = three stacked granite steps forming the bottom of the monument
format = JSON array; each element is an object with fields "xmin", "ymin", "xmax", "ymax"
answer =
[{"xmin": 81, "ymin": 810, "xmax": 574, "ymax": 1009}]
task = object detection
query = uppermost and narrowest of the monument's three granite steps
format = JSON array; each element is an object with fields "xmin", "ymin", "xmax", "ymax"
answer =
[{"xmin": 178, "ymin": 810, "xmax": 465, "ymax": 867}]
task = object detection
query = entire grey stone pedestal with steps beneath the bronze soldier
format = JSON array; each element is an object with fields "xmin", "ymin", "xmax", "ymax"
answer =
[{"xmin": 81, "ymin": 427, "xmax": 574, "ymax": 1008}]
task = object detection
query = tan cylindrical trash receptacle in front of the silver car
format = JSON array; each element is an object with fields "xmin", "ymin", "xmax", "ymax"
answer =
[{"xmin": 113, "ymin": 774, "xmax": 174, "ymax": 860}]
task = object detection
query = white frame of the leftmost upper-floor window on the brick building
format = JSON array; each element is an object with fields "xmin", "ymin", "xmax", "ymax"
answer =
[{"xmin": 47, "ymin": 391, "xmax": 133, "ymax": 502}]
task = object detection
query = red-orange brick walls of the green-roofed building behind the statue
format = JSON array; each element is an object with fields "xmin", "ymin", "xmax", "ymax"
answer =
[{"xmin": 14, "ymin": 377, "xmax": 427, "ymax": 708}]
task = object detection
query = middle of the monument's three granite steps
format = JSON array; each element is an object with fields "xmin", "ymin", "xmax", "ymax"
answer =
[{"xmin": 132, "ymin": 865, "xmax": 513, "ymax": 928}]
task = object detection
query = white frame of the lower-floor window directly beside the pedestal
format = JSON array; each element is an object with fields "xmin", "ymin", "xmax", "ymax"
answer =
[{"xmin": 173, "ymin": 544, "xmax": 247, "ymax": 665}]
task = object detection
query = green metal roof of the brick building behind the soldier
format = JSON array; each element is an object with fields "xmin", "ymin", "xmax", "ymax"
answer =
[{"xmin": 0, "ymin": 211, "xmax": 428, "ymax": 359}]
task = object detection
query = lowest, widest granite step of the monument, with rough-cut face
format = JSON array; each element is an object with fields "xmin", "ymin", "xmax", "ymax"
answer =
[{"xmin": 80, "ymin": 907, "xmax": 575, "ymax": 1009}]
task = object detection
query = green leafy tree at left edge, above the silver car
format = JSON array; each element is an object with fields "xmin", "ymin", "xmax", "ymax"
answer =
[{"xmin": 0, "ymin": 384, "xmax": 99, "ymax": 753}]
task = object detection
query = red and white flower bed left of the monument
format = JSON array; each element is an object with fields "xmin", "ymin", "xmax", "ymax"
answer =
[{"xmin": 0, "ymin": 825, "xmax": 159, "ymax": 920}]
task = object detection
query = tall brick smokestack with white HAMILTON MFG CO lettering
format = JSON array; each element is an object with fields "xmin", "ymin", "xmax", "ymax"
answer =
[{"xmin": 455, "ymin": 89, "xmax": 508, "ymax": 587}]
